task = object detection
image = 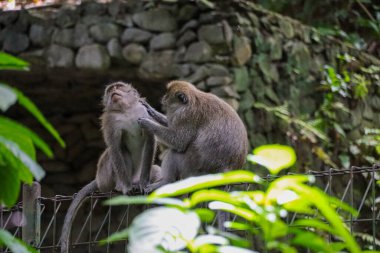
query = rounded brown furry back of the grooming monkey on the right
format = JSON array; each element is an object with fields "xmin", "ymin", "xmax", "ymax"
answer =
[{"xmin": 189, "ymin": 92, "xmax": 248, "ymax": 173}]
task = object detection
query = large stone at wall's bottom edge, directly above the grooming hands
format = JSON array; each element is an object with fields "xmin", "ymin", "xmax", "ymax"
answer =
[{"xmin": 138, "ymin": 50, "xmax": 175, "ymax": 81}]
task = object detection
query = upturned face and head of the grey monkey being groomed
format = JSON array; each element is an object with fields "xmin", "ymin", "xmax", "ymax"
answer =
[{"xmin": 103, "ymin": 82, "xmax": 140, "ymax": 111}]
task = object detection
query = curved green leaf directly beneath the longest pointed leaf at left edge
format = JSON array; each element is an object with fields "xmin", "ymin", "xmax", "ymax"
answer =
[{"xmin": 0, "ymin": 116, "xmax": 53, "ymax": 158}]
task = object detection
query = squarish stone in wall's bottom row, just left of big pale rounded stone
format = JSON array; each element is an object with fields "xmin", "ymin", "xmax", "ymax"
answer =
[{"xmin": 45, "ymin": 44, "xmax": 74, "ymax": 68}]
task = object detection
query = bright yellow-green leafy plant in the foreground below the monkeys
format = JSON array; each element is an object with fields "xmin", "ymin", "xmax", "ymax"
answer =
[{"xmin": 105, "ymin": 145, "xmax": 372, "ymax": 253}]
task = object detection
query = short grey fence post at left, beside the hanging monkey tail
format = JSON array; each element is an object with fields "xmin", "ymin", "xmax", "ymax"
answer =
[{"xmin": 22, "ymin": 182, "xmax": 41, "ymax": 246}]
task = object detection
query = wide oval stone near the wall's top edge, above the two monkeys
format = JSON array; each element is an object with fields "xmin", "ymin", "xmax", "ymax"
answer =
[{"xmin": 132, "ymin": 9, "xmax": 177, "ymax": 32}]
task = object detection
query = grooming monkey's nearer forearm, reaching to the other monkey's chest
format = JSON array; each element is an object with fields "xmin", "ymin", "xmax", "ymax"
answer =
[{"xmin": 138, "ymin": 118, "xmax": 196, "ymax": 152}]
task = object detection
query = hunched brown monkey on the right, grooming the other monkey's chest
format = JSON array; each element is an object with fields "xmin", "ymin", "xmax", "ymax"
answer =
[{"xmin": 138, "ymin": 81, "xmax": 248, "ymax": 191}]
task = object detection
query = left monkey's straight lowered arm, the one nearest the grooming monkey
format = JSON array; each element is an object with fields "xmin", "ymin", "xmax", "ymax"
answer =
[{"xmin": 140, "ymin": 131, "xmax": 156, "ymax": 189}]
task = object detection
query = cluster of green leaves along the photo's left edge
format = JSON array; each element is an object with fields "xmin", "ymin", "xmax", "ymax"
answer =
[{"xmin": 0, "ymin": 52, "xmax": 65, "ymax": 252}]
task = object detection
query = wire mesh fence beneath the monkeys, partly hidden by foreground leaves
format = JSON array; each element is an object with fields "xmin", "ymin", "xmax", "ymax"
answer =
[{"xmin": 0, "ymin": 165, "xmax": 380, "ymax": 253}]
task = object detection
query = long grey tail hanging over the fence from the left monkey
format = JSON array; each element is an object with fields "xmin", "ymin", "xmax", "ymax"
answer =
[{"xmin": 61, "ymin": 180, "xmax": 98, "ymax": 253}]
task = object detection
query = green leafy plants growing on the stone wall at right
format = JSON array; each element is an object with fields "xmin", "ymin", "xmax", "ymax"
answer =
[{"xmin": 254, "ymin": 53, "xmax": 380, "ymax": 168}]
